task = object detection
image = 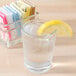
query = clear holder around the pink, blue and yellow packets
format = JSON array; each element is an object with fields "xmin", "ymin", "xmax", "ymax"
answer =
[{"xmin": 0, "ymin": 12, "xmax": 38, "ymax": 48}]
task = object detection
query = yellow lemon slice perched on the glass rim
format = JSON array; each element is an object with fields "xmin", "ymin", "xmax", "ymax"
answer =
[{"xmin": 37, "ymin": 20, "xmax": 73, "ymax": 37}]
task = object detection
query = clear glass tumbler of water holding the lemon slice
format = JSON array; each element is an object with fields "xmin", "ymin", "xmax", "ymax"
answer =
[{"xmin": 22, "ymin": 19, "xmax": 56, "ymax": 73}]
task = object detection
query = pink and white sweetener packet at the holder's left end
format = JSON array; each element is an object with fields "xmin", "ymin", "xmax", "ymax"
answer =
[{"xmin": 0, "ymin": 11, "xmax": 11, "ymax": 41}]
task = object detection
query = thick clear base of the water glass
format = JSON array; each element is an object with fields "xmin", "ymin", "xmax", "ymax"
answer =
[{"xmin": 24, "ymin": 63, "xmax": 52, "ymax": 74}]
